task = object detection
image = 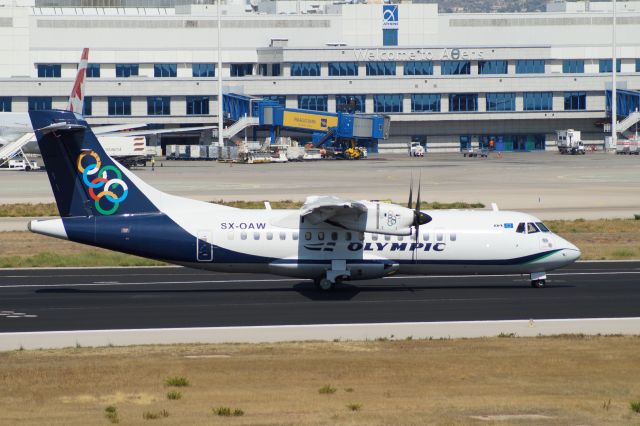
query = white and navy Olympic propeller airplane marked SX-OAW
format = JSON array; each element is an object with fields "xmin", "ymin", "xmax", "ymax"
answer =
[{"xmin": 29, "ymin": 111, "xmax": 580, "ymax": 290}]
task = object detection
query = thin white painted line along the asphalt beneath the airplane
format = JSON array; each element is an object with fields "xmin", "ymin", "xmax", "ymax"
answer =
[{"xmin": 0, "ymin": 271, "xmax": 640, "ymax": 289}]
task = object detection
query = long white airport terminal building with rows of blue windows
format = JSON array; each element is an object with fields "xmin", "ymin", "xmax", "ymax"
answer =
[{"xmin": 0, "ymin": 0, "xmax": 640, "ymax": 152}]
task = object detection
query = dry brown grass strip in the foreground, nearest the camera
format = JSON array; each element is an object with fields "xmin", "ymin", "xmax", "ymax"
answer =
[{"xmin": 0, "ymin": 336, "xmax": 640, "ymax": 425}]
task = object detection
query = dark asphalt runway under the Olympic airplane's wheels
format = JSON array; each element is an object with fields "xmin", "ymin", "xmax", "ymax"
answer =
[{"xmin": 0, "ymin": 262, "xmax": 640, "ymax": 332}]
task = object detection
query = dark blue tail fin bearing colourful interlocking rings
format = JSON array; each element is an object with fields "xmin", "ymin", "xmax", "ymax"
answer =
[{"xmin": 29, "ymin": 110, "xmax": 158, "ymax": 218}]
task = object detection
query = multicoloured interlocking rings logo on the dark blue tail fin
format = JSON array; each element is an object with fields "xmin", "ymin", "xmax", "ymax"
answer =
[{"xmin": 77, "ymin": 151, "xmax": 129, "ymax": 216}]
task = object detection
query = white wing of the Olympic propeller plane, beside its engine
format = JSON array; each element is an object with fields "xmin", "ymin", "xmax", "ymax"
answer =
[{"xmin": 300, "ymin": 196, "xmax": 368, "ymax": 230}]
